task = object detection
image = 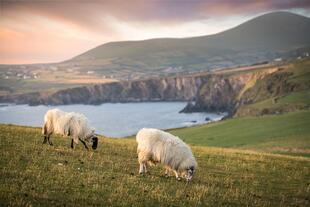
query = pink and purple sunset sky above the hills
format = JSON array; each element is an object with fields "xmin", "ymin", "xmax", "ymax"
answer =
[{"xmin": 0, "ymin": 0, "xmax": 310, "ymax": 64}]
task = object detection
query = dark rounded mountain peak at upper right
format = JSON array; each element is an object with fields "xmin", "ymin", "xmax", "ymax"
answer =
[{"xmin": 198, "ymin": 12, "xmax": 310, "ymax": 52}]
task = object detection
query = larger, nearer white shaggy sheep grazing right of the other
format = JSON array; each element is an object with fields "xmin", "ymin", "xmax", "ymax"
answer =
[{"xmin": 136, "ymin": 128, "xmax": 197, "ymax": 181}]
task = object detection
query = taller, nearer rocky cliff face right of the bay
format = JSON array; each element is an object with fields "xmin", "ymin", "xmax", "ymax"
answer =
[{"xmin": 181, "ymin": 69, "xmax": 276, "ymax": 115}]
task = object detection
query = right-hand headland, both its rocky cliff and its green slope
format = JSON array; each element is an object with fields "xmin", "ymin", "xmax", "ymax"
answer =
[{"xmin": 185, "ymin": 58, "xmax": 310, "ymax": 117}]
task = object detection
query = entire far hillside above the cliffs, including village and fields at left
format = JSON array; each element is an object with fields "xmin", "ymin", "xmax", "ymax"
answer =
[{"xmin": 0, "ymin": 12, "xmax": 310, "ymax": 96}]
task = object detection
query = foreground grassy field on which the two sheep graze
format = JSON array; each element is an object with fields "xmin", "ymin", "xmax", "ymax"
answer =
[{"xmin": 0, "ymin": 122, "xmax": 310, "ymax": 206}]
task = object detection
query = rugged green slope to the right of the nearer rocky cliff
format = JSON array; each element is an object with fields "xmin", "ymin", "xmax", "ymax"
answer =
[{"xmin": 234, "ymin": 59, "xmax": 310, "ymax": 117}]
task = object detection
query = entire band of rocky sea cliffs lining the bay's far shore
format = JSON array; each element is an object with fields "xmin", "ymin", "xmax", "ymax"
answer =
[{"xmin": 0, "ymin": 71, "xmax": 276, "ymax": 113}]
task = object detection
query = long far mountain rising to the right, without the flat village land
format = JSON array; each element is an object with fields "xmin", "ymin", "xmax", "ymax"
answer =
[{"xmin": 60, "ymin": 12, "xmax": 310, "ymax": 79}]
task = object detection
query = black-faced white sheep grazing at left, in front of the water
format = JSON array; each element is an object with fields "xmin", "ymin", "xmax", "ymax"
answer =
[{"xmin": 42, "ymin": 109, "xmax": 98, "ymax": 150}]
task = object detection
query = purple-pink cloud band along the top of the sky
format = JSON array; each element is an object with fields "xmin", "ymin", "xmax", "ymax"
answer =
[{"xmin": 2, "ymin": 0, "xmax": 310, "ymax": 24}]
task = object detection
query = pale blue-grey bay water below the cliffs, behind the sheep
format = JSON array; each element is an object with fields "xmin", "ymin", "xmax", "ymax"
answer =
[{"xmin": 0, "ymin": 102, "xmax": 225, "ymax": 137}]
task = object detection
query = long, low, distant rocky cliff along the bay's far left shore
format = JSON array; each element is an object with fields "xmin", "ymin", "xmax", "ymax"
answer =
[{"xmin": 0, "ymin": 77, "xmax": 203, "ymax": 105}]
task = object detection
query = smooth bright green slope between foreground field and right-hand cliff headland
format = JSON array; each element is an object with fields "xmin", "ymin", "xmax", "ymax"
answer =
[{"xmin": 171, "ymin": 110, "xmax": 310, "ymax": 156}]
